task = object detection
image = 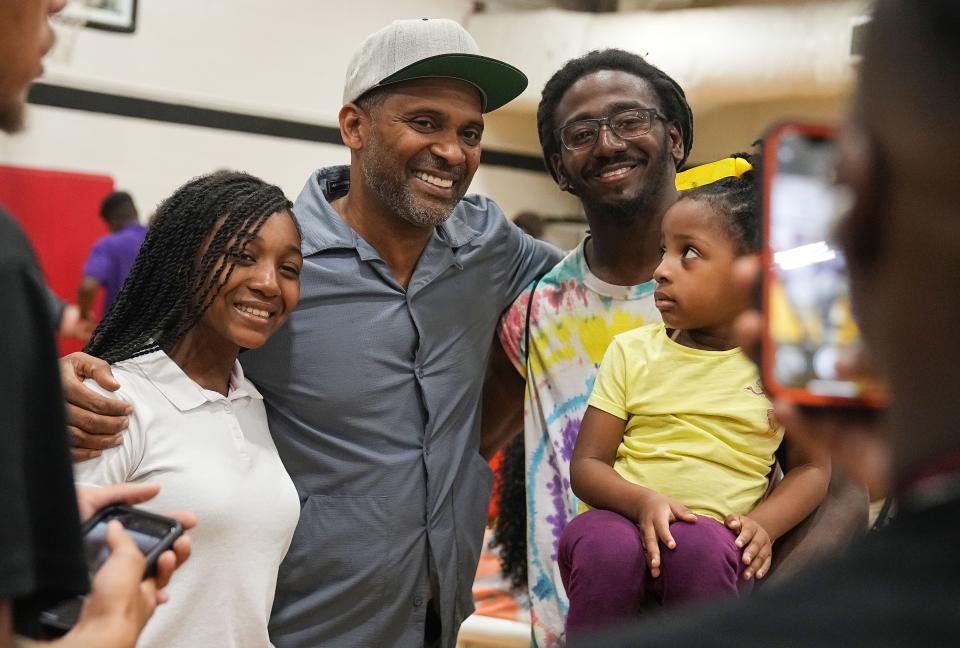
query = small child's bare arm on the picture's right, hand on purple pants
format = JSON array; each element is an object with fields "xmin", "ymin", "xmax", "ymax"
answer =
[{"xmin": 726, "ymin": 444, "xmax": 830, "ymax": 579}]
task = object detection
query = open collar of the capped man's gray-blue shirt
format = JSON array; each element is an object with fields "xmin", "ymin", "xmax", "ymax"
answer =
[{"xmin": 293, "ymin": 165, "xmax": 480, "ymax": 256}]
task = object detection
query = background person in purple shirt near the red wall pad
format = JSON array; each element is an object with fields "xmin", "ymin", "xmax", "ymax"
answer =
[{"xmin": 77, "ymin": 191, "xmax": 147, "ymax": 320}]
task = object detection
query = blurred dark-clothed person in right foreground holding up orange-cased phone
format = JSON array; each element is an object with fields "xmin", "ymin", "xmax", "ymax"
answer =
[{"xmin": 581, "ymin": 0, "xmax": 960, "ymax": 647}]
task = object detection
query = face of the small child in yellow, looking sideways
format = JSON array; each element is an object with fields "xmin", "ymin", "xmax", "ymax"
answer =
[{"xmin": 653, "ymin": 198, "xmax": 744, "ymax": 335}]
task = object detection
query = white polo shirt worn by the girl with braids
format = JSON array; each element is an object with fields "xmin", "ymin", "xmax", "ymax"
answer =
[{"xmin": 74, "ymin": 351, "xmax": 300, "ymax": 648}]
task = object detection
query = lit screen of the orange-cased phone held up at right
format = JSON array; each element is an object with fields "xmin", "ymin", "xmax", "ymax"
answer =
[{"xmin": 765, "ymin": 127, "xmax": 867, "ymax": 403}]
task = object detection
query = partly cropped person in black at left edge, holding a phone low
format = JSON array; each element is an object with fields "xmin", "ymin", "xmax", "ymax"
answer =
[{"xmin": 0, "ymin": 0, "xmax": 195, "ymax": 648}]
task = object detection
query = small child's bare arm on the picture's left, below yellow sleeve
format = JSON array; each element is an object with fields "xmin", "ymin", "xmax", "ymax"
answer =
[{"xmin": 570, "ymin": 406, "xmax": 697, "ymax": 578}]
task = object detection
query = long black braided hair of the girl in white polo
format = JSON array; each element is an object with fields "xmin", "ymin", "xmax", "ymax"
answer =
[{"xmin": 83, "ymin": 171, "xmax": 299, "ymax": 363}]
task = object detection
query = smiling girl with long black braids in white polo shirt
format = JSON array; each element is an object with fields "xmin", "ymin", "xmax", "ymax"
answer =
[{"xmin": 75, "ymin": 171, "xmax": 303, "ymax": 648}]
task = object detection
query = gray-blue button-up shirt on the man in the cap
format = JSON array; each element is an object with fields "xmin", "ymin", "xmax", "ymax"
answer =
[{"xmin": 241, "ymin": 167, "xmax": 560, "ymax": 647}]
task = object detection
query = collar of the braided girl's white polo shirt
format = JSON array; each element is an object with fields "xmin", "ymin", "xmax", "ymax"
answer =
[{"xmin": 128, "ymin": 351, "xmax": 263, "ymax": 412}]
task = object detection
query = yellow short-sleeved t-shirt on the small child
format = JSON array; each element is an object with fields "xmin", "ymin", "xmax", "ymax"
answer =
[{"xmin": 589, "ymin": 324, "xmax": 783, "ymax": 522}]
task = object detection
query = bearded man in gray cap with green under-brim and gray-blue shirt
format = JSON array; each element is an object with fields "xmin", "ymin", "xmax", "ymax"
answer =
[{"xmin": 67, "ymin": 13, "xmax": 561, "ymax": 648}]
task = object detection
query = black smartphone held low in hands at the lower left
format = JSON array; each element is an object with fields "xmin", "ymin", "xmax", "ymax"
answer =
[{"xmin": 40, "ymin": 504, "xmax": 183, "ymax": 636}]
